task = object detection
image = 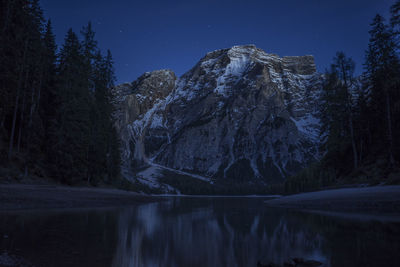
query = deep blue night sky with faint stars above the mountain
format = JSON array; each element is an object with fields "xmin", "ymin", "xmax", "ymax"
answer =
[{"xmin": 41, "ymin": 0, "xmax": 394, "ymax": 83}]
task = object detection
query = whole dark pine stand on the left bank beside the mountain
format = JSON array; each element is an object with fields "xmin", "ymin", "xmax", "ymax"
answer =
[{"xmin": 0, "ymin": 0, "xmax": 120, "ymax": 184}]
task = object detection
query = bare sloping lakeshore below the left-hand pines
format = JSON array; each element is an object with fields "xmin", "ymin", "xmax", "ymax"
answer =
[{"xmin": 0, "ymin": 184, "xmax": 156, "ymax": 211}]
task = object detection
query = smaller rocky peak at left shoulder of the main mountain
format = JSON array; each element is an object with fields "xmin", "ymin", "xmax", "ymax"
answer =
[{"xmin": 112, "ymin": 70, "xmax": 176, "ymax": 168}]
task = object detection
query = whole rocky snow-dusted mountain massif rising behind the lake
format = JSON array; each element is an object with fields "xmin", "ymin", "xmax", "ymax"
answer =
[{"xmin": 117, "ymin": 45, "xmax": 322, "ymax": 184}]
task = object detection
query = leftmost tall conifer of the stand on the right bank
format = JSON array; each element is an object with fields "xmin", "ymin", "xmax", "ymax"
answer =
[{"xmin": 320, "ymin": 52, "xmax": 359, "ymax": 171}]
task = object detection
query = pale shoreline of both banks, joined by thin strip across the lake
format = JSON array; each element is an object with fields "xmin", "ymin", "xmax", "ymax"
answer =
[{"xmin": 0, "ymin": 184, "xmax": 400, "ymax": 215}]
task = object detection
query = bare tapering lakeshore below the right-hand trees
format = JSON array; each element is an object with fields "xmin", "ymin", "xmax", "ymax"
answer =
[{"xmin": 265, "ymin": 185, "xmax": 400, "ymax": 214}]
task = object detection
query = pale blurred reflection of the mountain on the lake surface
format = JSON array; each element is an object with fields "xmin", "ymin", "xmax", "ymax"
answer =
[{"xmin": 113, "ymin": 199, "xmax": 329, "ymax": 266}]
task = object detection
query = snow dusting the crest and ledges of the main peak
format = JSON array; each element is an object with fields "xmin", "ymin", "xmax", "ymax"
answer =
[{"xmin": 120, "ymin": 46, "xmax": 320, "ymax": 183}]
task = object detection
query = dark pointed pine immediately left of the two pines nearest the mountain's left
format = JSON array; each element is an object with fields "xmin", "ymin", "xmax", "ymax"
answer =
[{"xmin": 52, "ymin": 29, "xmax": 90, "ymax": 183}]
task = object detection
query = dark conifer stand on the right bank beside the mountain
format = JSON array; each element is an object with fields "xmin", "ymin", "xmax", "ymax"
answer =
[{"xmin": 284, "ymin": 1, "xmax": 400, "ymax": 193}]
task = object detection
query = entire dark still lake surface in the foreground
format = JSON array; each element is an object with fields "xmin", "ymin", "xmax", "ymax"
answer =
[{"xmin": 0, "ymin": 198, "xmax": 400, "ymax": 267}]
